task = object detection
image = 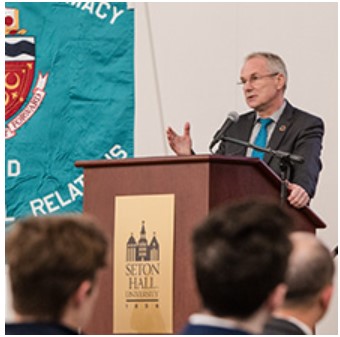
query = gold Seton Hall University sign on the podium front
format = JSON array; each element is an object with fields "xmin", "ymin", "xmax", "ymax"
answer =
[{"xmin": 113, "ymin": 194, "xmax": 175, "ymax": 334}]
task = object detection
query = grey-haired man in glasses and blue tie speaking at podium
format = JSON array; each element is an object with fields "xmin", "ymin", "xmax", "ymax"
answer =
[{"xmin": 167, "ymin": 52, "xmax": 324, "ymax": 208}]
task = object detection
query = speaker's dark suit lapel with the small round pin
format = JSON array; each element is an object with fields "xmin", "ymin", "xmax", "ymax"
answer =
[{"xmin": 263, "ymin": 102, "xmax": 294, "ymax": 164}]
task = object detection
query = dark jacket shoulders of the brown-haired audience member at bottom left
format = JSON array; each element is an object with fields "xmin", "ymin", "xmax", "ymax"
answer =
[{"xmin": 5, "ymin": 322, "xmax": 78, "ymax": 335}]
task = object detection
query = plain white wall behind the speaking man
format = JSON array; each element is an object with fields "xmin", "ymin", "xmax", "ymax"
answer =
[{"xmin": 134, "ymin": 2, "xmax": 338, "ymax": 334}]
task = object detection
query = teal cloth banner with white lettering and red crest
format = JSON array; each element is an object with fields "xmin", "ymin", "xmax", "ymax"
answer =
[{"xmin": 5, "ymin": 2, "xmax": 134, "ymax": 226}]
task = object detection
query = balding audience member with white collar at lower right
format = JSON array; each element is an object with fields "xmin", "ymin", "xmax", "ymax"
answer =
[{"xmin": 264, "ymin": 232, "xmax": 334, "ymax": 335}]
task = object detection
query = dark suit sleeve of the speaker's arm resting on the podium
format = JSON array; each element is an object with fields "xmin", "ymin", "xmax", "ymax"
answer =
[{"xmin": 291, "ymin": 117, "xmax": 324, "ymax": 198}]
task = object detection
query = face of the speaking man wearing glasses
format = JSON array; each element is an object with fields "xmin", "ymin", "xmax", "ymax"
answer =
[{"xmin": 240, "ymin": 57, "xmax": 283, "ymax": 112}]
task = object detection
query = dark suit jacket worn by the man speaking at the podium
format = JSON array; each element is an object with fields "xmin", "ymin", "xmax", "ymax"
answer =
[{"xmin": 216, "ymin": 102, "xmax": 324, "ymax": 198}]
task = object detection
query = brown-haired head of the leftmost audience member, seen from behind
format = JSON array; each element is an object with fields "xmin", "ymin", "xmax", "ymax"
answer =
[{"xmin": 6, "ymin": 215, "xmax": 107, "ymax": 328}]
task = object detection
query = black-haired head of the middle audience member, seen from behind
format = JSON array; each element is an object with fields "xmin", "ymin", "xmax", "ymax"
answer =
[{"xmin": 193, "ymin": 201, "xmax": 292, "ymax": 330}]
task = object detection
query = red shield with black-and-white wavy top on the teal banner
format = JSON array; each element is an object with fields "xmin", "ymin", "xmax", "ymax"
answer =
[{"xmin": 5, "ymin": 36, "xmax": 35, "ymax": 120}]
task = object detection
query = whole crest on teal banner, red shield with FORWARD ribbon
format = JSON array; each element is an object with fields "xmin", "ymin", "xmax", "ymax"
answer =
[{"xmin": 5, "ymin": 8, "xmax": 48, "ymax": 139}]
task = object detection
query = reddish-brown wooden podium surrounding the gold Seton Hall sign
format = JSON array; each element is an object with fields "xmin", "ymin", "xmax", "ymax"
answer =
[{"xmin": 76, "ymin": 155, "xmax": 326, "ymax": 334}]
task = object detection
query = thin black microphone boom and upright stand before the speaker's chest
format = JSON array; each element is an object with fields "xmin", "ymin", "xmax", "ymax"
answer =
[{"xmin": 221, "ymin": 137, "xmax": 304, "ymax": 206}]
